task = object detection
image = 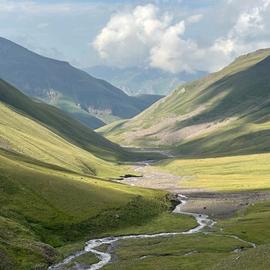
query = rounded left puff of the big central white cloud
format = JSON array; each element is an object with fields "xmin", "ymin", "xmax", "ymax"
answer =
[{"xmin": 93, "ymin": 4, "xmax": 167, "ymax": 66}]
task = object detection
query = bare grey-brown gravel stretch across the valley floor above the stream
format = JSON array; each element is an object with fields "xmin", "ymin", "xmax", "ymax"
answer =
[{"xmin": 119, "ymin": 165, "xmax": 270, "ymax": 218}]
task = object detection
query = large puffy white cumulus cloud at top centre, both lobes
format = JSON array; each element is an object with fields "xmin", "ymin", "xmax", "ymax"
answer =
[{"xmin": 93, "ymin": 4, "xmax": 201, "ymax": 72}]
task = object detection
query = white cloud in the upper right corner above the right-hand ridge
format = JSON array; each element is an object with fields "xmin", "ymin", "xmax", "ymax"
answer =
[{"xmin": 206, "ymin": 0, "xmax": 270, "ymax": 71}]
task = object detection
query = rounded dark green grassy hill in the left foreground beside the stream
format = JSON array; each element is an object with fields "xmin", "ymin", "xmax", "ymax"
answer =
[{"xmin": 0, "ymin": 150, "xmax": 166, "ymax": 270}]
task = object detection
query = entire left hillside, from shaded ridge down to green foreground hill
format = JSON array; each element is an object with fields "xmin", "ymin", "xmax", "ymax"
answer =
[{"xmin": 0, "ymin": 77, "xmax": 167, "ymax": 270}]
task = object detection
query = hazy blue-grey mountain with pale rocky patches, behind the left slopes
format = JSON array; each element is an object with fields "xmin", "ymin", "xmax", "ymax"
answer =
[{"xmin": 0, "ymin": 38, "xmax": 160, "ymax": 128}]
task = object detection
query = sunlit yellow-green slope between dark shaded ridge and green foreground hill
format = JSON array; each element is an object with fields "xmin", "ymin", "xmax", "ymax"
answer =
[{"xmin": 0, "ymin": 100, "xmax": 129, "ymax": 176}]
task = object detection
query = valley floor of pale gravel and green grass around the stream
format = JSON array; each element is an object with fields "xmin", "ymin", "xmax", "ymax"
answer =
[{"xmin": 52, "ymin": 159, "xmax": 270, "ymax": 270}]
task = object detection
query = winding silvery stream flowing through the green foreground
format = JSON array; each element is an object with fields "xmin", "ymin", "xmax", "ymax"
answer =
[{"xmin": 48, "ymin": 194, "xmax": 215, "ymax": 270}]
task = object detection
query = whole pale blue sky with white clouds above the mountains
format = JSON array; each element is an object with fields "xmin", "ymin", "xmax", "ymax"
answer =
[{"xmin": 0, "ymin": 0, "xmax": 270, "ymax": 73}]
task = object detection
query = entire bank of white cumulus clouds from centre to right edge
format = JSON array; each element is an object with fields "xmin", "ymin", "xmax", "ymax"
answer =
[{"xmin": 93, "ymin": 0, "xmax": 270, "ymax": 73}]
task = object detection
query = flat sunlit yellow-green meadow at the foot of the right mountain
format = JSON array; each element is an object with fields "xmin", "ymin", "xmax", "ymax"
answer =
[{"xmin": 158, "ymin": 154, "xmax": 270, "ymax": 191}]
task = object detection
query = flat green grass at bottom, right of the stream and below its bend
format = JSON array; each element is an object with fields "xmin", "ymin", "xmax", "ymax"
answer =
[{"xmin": 104, "ymin": 234, "xmax": 248, "ymax": 270}]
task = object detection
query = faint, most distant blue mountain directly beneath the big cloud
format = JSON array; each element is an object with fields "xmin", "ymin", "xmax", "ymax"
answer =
[{"xmin": 85, "ymin": 66, "xmax": 206, "ymax": 96}]
